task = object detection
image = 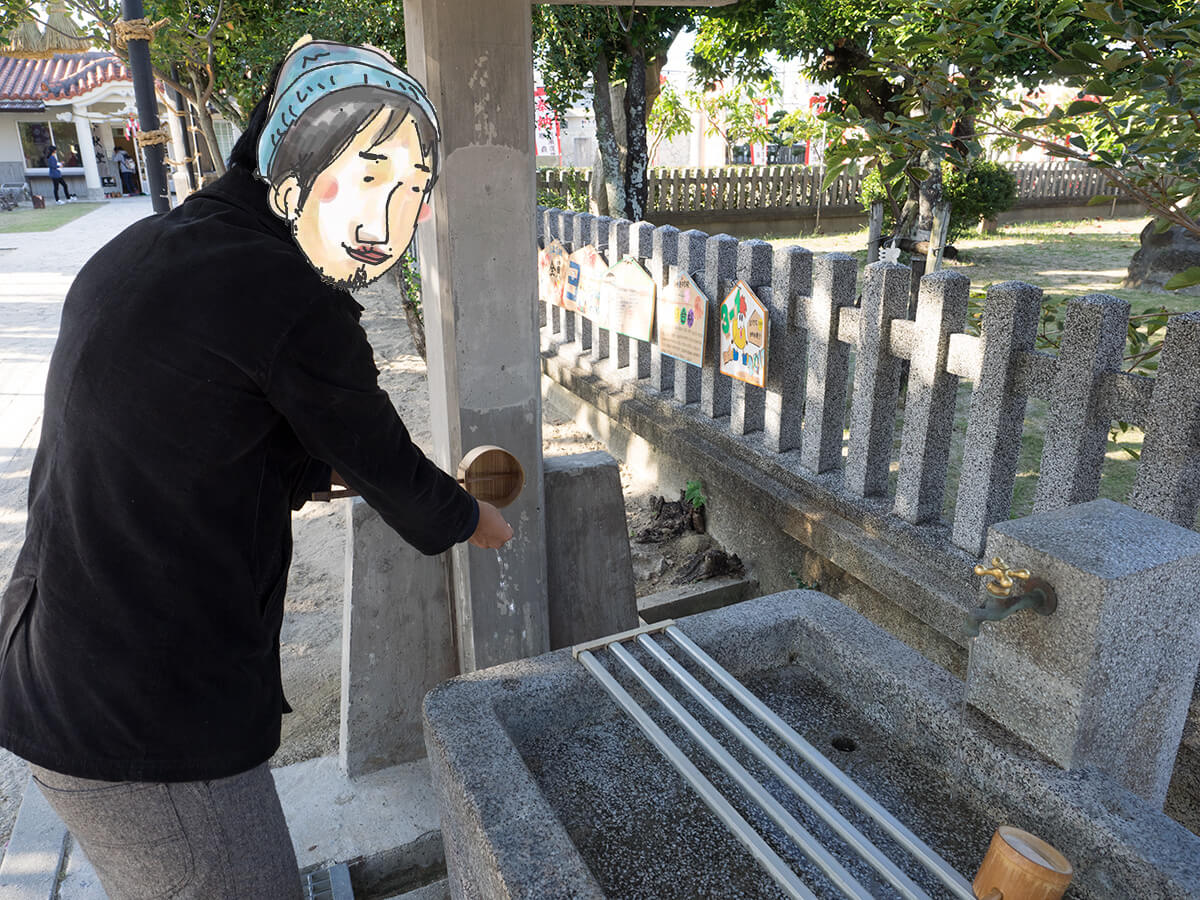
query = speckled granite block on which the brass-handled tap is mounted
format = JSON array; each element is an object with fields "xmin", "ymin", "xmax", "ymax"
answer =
[{"xmin": 967, "ymin": 500, "xmax": 1200, "ymax": 809}]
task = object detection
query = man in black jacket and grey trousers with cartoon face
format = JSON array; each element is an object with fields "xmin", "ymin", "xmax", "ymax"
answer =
[{"xmin": 0, "ymin": 38, "xmax": 512, "ymax": 900}]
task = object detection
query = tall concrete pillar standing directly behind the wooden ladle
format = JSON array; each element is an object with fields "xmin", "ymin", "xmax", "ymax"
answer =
[{"xmin": 404, "ymin": 0, "xmax": 550, "ymax": 672}]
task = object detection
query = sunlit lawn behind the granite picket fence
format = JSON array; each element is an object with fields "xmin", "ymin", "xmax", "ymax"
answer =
[{"xmin": 770, "ymin": 218, "xmax": 1200, "ymax": 532}]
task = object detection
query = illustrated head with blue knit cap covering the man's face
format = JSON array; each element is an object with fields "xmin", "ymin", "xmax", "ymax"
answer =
[{"xmin": 258, "ymin": 38, "xmax": 440, "ymax": 289}]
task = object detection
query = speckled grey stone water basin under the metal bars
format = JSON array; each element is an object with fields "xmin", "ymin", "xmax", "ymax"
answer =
[{"xmin": 425, "ymin": 590, "xmax": 1200, "ymax": 900}]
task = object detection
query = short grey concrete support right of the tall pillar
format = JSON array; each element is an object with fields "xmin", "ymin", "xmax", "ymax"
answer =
[{"xmin": 546, "ymin": 451, "xmax": 637, "ymax": 649}]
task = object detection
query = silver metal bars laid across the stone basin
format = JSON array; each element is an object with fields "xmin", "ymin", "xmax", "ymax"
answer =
[{"xmin": 574, "ymin": 620, "xmax": 974, "ymax": 900}]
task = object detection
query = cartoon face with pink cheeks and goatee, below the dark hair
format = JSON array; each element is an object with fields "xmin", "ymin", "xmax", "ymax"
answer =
[{"xmin": 271, "ymin": 110, "xmax": 431, "ymax": 288}]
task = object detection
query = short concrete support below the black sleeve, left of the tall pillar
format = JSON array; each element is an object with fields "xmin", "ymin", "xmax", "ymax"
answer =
[{"xmin": 337, "ymin": 499, "xmax": 457, "ymax": 778}]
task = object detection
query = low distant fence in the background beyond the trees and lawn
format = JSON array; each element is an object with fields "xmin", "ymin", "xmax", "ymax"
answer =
[{"xmin": 538, "ymin": 162, "xmax": 1114, "ymax": 218}]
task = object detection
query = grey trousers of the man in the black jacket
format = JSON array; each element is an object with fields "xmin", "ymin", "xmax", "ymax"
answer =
[{"xmin": 30, "ymin": 762, "xmax": 301, "ymax": 900}]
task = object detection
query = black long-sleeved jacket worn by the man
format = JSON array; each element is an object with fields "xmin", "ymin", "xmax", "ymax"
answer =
[{"xmin": 0, "ymin": 167, "xmax": 479, "ymax": 781}]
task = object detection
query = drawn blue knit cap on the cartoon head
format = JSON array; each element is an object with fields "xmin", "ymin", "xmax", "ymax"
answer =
[{"xmin": 258, "ymin": 41, "xmax": 440, "ymax": 179}]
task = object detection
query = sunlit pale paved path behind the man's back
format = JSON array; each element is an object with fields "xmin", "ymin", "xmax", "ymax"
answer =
[{"xmin": 0, "ymin": 197, "xmax": 151, "ymax": 846}]
